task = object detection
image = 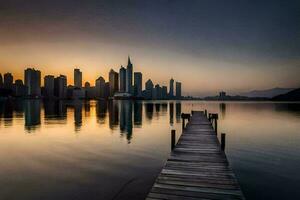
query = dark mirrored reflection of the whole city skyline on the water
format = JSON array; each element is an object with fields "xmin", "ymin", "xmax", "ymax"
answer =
[{"xmin": 0, "ymin": 99, "xmax": 181, "ymax": 142}]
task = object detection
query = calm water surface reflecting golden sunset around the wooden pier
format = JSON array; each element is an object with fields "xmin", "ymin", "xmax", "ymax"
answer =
[{"xmin": 0, "ymin": 100, "xmax": 300, "ymax": 200}]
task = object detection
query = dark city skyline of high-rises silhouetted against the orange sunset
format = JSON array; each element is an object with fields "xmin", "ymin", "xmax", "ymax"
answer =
[{"xmin": 0, "ymin": 56, "xmax": 183, "ymax": 100}]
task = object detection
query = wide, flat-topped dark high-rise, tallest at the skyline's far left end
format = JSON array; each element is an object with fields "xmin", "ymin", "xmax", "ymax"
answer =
[{"xmin": 24, "ymin": 68, "xmax": 41, "ymax": 96}]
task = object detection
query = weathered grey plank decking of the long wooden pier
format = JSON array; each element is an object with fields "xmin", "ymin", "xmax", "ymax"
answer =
[{"xmin": 146, "ymin": 111, "xmax": 244, "ymax": 200}]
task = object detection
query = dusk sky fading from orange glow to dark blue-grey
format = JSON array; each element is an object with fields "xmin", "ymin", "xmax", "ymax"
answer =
[{"xmin": 0, "ymin": 0, "xmax": 300, "ymax": 96}]
